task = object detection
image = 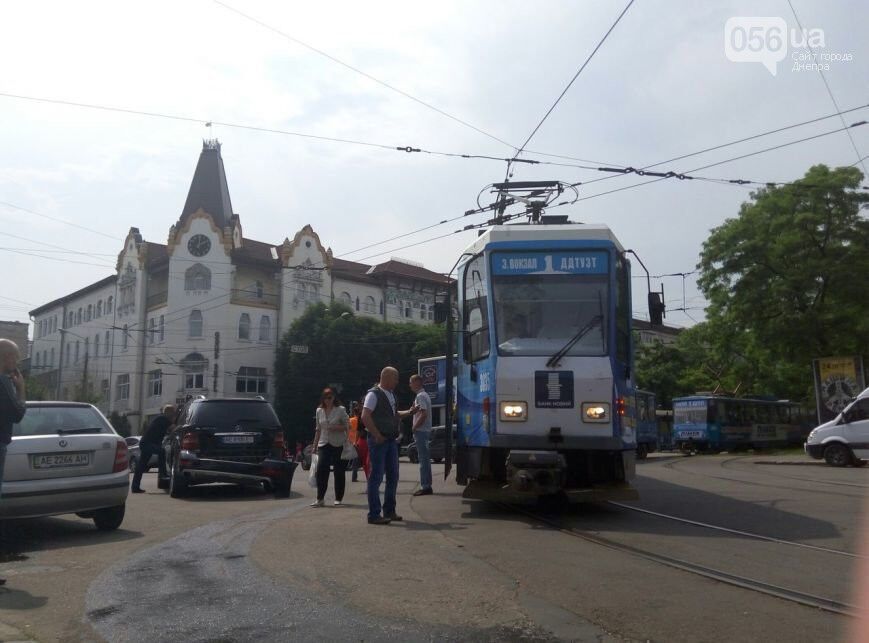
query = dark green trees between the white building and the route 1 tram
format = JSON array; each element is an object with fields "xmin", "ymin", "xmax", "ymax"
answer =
[{"xmin": 275, "ymin": 303, "xmax": 445, "ymax": 443}]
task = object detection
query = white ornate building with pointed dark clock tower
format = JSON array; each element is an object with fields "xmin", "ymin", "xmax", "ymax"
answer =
[{"xmin": 30, "ymin": 141, "xmax": 448, "ymax": 430}]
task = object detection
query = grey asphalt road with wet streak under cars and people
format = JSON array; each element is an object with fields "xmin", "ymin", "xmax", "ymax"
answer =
[{"xmin": 0, "ymin": 455, "xmax": 869, "ymax": 641}]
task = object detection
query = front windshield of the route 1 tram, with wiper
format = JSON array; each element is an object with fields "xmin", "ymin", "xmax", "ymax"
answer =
[{"xmin": 494, "ymin": 275, "xmax": 609, "ymax": 357}]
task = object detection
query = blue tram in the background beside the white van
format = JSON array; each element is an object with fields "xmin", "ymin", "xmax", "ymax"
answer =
[{"xmin": 673, "ymin": 395, "xmax": 813, "ymax": 452}]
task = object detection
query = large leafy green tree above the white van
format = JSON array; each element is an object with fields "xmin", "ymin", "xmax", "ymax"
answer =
[{"xmin": 698, "ymin": 165, "xmax": 869, "ymax": 400}]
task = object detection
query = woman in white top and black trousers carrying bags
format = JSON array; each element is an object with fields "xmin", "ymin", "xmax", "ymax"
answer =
[{"xmin": 311, "ymin": 386, "xmax": 350, "ymax": 507}]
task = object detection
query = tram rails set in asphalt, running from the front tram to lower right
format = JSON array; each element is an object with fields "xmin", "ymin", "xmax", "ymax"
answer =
[{"xmin": 506, "ymin": 503, "xmax": 862, "ymax": 617}]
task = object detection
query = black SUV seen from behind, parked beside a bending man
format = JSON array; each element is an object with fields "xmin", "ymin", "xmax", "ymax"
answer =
[{"xmin": 158, "ymin": 398, "xmax": 296, "ymax": 498}]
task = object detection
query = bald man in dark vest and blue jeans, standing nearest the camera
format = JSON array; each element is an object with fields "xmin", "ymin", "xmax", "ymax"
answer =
[{"xmin": 362, "ymin": 366, "xmax": 401, "ymax": 525}]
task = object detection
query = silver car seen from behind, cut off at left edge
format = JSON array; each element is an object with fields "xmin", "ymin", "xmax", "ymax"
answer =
[{"xmin": 0, "ymin": 402, "xmax": 130, "ymax": 530}]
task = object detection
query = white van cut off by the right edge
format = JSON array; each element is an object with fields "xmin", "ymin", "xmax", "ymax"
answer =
[{"xmin": 805, "ymin": 388, "xmax": 869, "ymax": 467}]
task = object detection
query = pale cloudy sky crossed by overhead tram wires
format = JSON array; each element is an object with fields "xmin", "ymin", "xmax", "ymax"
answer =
[{"xmin": 0, "ymin": 0, "xmax": 869, "ymax": 326}]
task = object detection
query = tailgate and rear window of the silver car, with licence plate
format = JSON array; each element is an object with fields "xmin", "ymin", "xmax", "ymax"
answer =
[{"xmin": 3, "ymin": 403, "xmax": 118, "ymax": 482}]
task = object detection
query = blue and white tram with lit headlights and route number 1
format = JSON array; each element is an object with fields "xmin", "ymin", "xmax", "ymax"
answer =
[{"xmin": 456, "ymin": 224, "xmax": 637, "ymax": 502}]
